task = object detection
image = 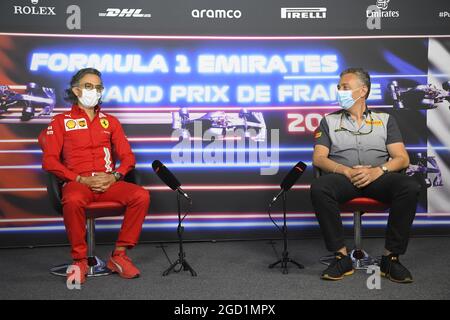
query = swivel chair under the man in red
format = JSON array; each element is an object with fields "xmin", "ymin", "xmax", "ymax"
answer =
[{"xmin": 47, "ymin": 170, "xmax": 140, "ymax": 277}]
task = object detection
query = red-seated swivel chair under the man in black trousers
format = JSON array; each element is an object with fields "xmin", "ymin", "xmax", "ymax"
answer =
[{"xmin": 314, "ymin": 167, "xmax": 389, "ymax": 270}]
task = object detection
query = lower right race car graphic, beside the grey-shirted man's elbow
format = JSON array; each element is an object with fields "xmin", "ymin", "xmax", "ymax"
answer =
[{"xmin": 406, "ymin": 153, "xmax": 444, "ymax": 188}]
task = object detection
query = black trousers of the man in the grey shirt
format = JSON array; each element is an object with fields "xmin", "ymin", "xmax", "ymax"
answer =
[{"xmin": 311, "ymin": 172, "xmax": 421, "ymax": 254}]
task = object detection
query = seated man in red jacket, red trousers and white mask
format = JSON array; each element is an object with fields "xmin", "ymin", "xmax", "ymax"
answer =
[{"xmin": 39, "ymin": 68, "xmax": 150, "ymax": 283}]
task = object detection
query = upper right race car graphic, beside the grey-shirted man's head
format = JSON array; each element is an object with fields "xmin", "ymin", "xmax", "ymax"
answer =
[{"xmin": 388, "ymin": 81, "xmax": 450, "ymax": 110}]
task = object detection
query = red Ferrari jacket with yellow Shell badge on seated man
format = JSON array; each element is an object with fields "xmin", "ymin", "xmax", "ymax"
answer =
[{"xmin": 39, "ymin": 105, "xmax": 136, "ymax": 181}]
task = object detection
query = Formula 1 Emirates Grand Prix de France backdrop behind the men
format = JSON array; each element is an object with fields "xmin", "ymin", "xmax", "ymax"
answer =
[{"xmin": 0, "ymin": 0, "xmax": 450, "ymax": 247}]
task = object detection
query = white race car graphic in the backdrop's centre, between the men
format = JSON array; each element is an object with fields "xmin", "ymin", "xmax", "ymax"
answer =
[{"xmin": 172, "ymin": 108, "xmax": 267, "ymax": 141}]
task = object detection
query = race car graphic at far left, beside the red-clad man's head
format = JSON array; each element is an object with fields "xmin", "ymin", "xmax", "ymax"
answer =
[{"xmin": 0, "ymin": 82, "xmax": 56, "ymax": 121}]
